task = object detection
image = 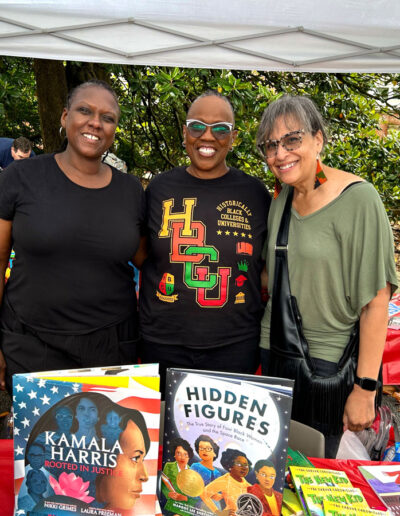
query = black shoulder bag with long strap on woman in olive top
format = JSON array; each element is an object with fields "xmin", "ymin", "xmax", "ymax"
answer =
[{"xmin": 268, "ymin": 188, "xmax": 359, "ymax": 435}]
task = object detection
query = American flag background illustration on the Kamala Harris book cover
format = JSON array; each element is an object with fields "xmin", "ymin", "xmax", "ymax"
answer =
[{"xmin": 13, "ymin": 374, "xmax": 160, "ymax": 516}]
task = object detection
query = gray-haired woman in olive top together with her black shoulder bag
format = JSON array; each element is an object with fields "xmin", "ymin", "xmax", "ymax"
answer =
[{"xmin": 257, "ymin": 95, "xmax": 397, "ymax": 458}]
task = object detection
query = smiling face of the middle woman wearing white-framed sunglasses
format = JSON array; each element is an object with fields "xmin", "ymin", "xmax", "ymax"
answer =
[{"xmin": 183, "ymin": 95, "xmax": 237, "ymax": 179}]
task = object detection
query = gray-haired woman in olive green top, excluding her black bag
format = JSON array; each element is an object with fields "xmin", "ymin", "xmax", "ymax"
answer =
[{"xmin": 257, "ymin": 96, "xmax": 397, "ymax": 456}]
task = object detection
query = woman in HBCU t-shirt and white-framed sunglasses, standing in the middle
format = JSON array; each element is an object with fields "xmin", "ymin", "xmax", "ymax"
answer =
[{"xmin": 140, "ymin": 91, "xmax": 270, "ymax": 389}]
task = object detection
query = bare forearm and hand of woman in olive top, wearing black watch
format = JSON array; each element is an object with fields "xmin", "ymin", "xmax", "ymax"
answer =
[{"xmin": 343, "ymin": 283, "xmax": 391, "ymax": 432}]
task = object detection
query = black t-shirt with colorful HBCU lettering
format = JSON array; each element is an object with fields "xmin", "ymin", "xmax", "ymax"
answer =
[{"xmin": 140, "ymin": 167, "xmax": 271, "ymax": 348}]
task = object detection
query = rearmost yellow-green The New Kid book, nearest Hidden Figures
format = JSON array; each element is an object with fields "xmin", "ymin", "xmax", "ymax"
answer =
[{"xmin": 289, "ymin": 466, "xmax": 352, "ymax": 512}]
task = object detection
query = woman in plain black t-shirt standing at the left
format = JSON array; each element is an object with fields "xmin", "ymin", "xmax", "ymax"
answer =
[{"xmin": 0, "ymin": 80, "xmax": 144, "ymax": 389}]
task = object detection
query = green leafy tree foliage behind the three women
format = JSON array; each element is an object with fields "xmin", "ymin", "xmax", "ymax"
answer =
[{"xmin": 0, "ymin": 58, "xmax": 400, "ymax": 220}]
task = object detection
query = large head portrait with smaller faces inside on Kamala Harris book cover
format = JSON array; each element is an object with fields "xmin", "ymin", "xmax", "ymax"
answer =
[{"xmin": 23, "ymin": 392, "xmax": 150, "ymax": 516}]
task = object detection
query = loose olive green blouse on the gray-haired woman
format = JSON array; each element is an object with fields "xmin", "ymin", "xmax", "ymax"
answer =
[{"xmin": 260, "ymin": 182, "xmax": 397, "ymax": 362}]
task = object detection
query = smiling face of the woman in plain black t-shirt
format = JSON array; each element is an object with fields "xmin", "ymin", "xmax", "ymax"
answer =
[{"xmin": 61, "ymin": 86, "xmax": 119, "ymax": 159}]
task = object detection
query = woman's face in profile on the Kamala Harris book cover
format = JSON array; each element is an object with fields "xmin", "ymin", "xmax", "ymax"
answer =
[{"xmin": 96, "ymin": 420, "xmax": 149, "ymax": 510}]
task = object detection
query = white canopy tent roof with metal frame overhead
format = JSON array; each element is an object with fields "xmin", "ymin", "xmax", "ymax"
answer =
[{"xmin": 0, "ymin": 0, "xmax": 400, "ymax": 72}]
